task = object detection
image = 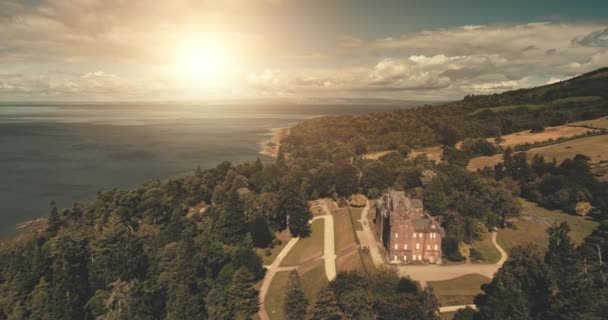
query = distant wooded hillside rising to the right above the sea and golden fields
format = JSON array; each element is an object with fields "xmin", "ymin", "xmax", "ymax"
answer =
[{"xmin": 282, "ymin": 68, "xmax": 608, "ymax": 160}]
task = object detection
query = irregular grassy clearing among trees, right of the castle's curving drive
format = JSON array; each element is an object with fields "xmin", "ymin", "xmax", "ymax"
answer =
[{"xmin": 498, "ymin": 199, "xmax": 598, "ymax": 252}]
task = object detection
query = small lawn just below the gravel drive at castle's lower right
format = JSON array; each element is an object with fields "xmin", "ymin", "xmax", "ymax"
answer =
[{"xmin": 428, "ymin": 274, "xmax": 490, "ymax": 306}]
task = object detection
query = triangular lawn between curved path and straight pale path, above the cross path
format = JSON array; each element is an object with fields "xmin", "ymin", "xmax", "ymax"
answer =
[{"xmin": 281, "ymin": 219, "xmax": 325, "ymax": 267}]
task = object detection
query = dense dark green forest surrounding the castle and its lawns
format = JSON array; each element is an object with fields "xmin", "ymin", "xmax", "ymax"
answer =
[{"xmin": 0, "ymin": 69, "xmax": 608, "ymax": 320}]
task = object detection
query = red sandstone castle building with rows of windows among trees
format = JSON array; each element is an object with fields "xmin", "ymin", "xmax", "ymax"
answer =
[{"xmin": 374, "ymin": 190, "xmax": 443, "ymax": 264}]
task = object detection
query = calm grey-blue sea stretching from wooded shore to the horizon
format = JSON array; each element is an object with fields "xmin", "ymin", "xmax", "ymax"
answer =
[{"xmin": 0, "ymin": 102, "xmax": 416, "ymax": 235}]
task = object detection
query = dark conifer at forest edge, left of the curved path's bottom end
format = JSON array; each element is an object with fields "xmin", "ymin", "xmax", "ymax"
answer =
[{"xmin": 229, "ymin": 267, "xmax": 260, "ymax": 319}]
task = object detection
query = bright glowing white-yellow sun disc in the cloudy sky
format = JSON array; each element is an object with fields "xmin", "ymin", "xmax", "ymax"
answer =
[{"xmin": 175, "ymin": 37, "xmax": 232, "ymax": 86}]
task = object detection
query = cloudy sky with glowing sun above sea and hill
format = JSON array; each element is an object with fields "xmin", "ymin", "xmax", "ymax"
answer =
[{"xmin": 0, "ymin": 0, "xmax": 608, "ymax": 102}]
